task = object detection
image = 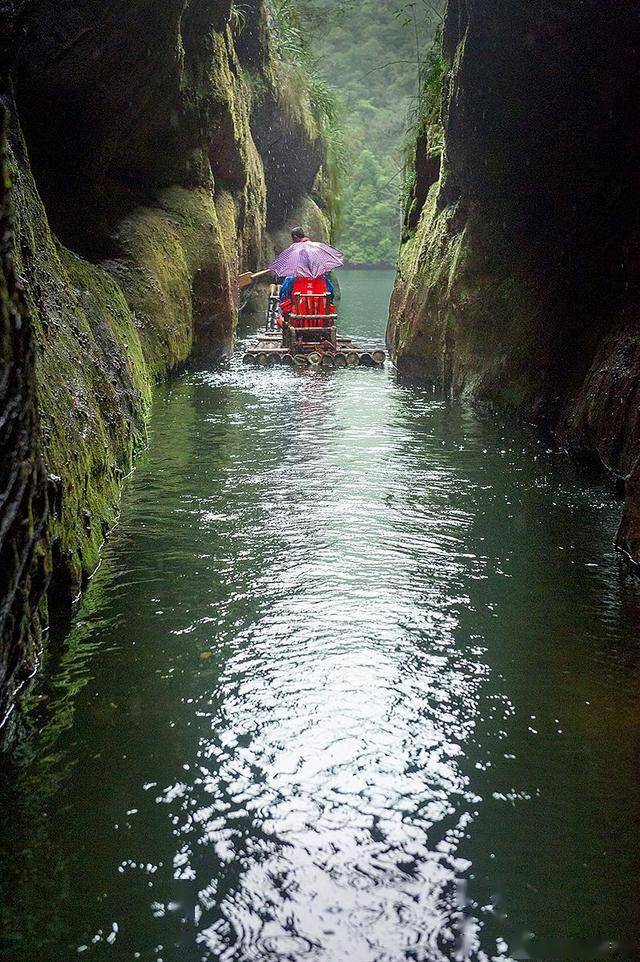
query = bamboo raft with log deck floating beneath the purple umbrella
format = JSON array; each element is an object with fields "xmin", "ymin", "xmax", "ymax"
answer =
[{"xmin": 243, "ymin": 285, "xmax": 386, "ymax": 369}]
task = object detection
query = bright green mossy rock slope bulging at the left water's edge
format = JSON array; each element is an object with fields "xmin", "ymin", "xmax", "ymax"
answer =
[{"xmin": 10, "ymin": 118, "xmax": 150, "ymax": 610}]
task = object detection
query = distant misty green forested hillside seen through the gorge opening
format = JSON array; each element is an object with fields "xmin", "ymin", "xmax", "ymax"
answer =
[{"xmin": 296, "ymin": 0, "xmax": 439, "ymax": 264}]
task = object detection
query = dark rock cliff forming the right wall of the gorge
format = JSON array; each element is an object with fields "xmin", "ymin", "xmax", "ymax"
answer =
[{"xmin": 387, "ymin": 0, "xmax": 640, "ymax": 556}]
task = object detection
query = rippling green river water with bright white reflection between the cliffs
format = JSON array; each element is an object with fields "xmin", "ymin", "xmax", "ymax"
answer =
[{"xmin": 0, "ymin": 272, "xmax": 640, "ymax": 962}]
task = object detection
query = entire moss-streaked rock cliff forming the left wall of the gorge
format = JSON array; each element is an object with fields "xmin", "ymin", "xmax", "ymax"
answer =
[{"xmin": 0, "ymin": 0, "xmax": 338, "ymax": 720}]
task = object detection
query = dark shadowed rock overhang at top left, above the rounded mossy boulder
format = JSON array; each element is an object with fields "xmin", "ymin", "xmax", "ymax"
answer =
[{"xmin": 8, "ymin": 0, "xmax": 231, "ymax": 259}]
